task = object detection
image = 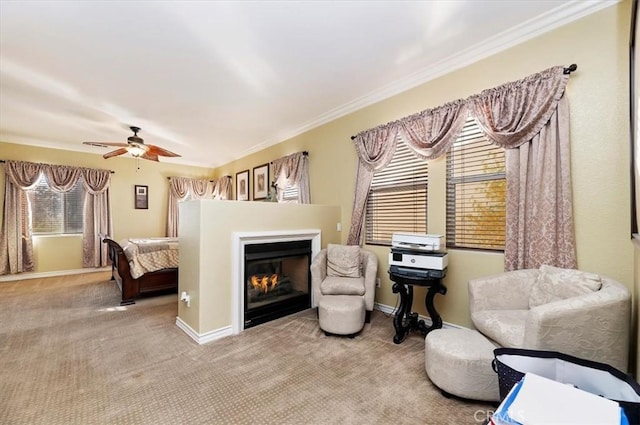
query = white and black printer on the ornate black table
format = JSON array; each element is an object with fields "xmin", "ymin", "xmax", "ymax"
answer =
[{"xmin": 389, "ymin": 233, "xmax": 449, "ymax": 277}]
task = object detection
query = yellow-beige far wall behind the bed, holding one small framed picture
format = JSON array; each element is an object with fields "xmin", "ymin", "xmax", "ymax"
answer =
[{"xmin": 0, "ymin": 142, "xmax": 213, "ymax": 273}]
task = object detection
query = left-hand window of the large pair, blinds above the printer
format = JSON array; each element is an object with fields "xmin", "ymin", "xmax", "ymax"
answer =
[{"xmin": 366, "ymin": 141, "xmax": 428, "ymax": 245}]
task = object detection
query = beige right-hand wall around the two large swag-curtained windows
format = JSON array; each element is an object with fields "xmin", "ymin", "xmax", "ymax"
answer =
[{"xmin": 216, "ymin": 1, "xmax": 634, "ymax": 344}]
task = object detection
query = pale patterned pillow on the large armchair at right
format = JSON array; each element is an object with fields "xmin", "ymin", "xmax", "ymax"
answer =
[{"xmin": 529, "ymin": 264, "xmax": 602, "ymax": 308}]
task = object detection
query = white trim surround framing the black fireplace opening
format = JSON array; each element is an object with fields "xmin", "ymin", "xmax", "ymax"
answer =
[{"xmin": 231, "ymin": 229, "xmax": 321, "ymax": 335}]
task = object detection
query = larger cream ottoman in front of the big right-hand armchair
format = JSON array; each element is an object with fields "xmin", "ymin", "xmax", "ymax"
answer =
[{"xmin": 424, "ymin": 329, "xmax": 500, "ymax": 401}]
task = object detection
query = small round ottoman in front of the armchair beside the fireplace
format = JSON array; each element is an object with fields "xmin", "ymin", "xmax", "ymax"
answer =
[{"xmin": 318, "ymin": 295, "xmax": 365, "ymax": 338}]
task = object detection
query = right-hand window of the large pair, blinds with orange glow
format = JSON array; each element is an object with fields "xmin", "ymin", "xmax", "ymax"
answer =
[{"xmin": 446, "ymin": 117, "xmax": 506, "ymax": 250}]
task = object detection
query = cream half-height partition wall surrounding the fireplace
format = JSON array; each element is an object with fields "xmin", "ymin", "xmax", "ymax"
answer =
[{"xmin": 178, "ymin": 200, "xmax": 340, "ymax": 335}]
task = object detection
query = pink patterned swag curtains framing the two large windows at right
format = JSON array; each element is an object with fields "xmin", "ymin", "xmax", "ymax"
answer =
[{"xmin": 347, "ymin": 66, "xmax": 577, "ymax": 270}]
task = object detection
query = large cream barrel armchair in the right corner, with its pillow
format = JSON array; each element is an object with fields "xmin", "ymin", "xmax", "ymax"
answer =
[{"xmin": 469, "ymin": 266, "xmax": 631, "ymax": 371}]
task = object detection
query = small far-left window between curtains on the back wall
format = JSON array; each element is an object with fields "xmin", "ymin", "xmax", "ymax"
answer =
[{"xmin": 27, "ymin": 176, "xmax": 84, "ymax": 235}]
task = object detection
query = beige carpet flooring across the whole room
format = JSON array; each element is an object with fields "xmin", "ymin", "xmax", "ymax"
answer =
[{"xmin": 0, "ymin": 273, "xmax": 493, "ymax": 425}]
